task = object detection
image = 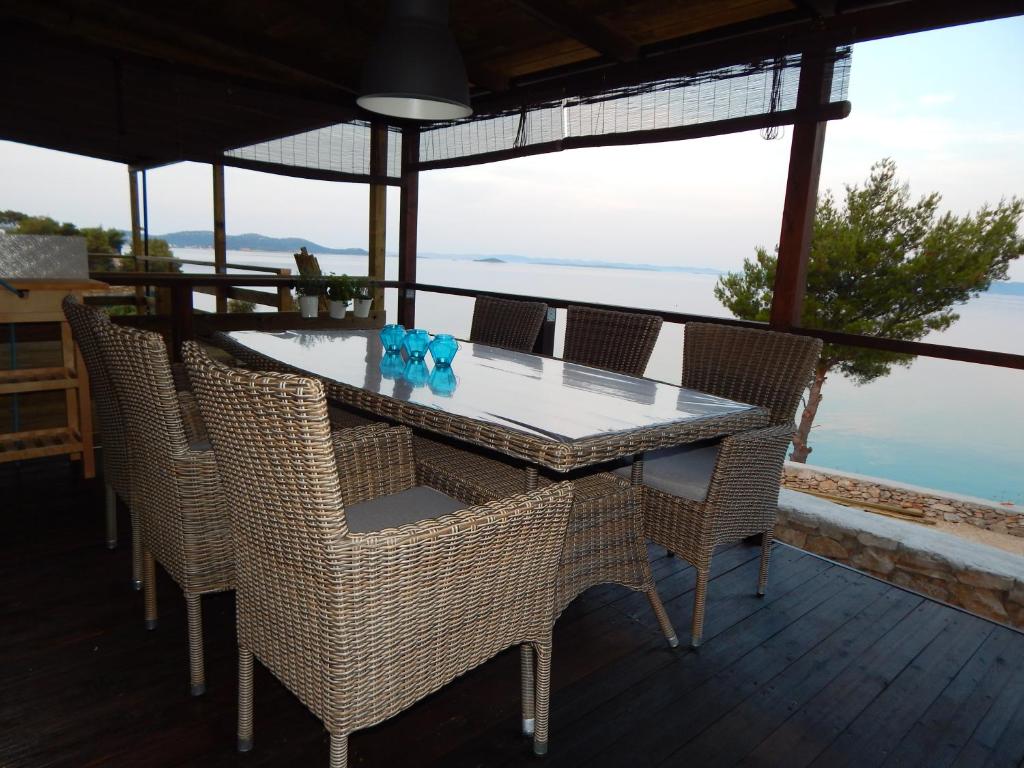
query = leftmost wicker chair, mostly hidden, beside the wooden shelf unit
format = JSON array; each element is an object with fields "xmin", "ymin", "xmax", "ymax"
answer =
[{"xmin": 63, "ymin": 296, "xmax": 132, "ymax": 557}]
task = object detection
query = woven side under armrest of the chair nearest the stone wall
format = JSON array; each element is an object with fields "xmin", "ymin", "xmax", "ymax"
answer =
[{"xmin": 707, "ymin": 424, "xmax": 796, "ymax": 529}]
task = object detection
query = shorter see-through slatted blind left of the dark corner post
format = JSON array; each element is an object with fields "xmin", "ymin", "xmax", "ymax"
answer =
[{"xmin": 224, "ymin": 122, "xmax": 401, "ymax": 176}]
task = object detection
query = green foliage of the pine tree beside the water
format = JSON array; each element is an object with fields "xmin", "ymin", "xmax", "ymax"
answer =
[{"xmin": 715, "ymin": 159, "xmax": 1024, "ymax": 384}]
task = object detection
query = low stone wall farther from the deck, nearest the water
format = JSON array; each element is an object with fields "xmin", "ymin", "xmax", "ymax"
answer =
[{"xmin": 782, "ymin": 462, "xmax": 1024, "ymax": 538}]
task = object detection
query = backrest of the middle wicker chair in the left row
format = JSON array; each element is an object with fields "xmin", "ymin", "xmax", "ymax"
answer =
[{"xmin": 96, "ymin": 323, "xmax": 195, "ymax": 580}]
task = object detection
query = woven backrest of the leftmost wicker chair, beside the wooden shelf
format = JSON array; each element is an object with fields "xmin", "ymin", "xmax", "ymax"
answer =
[{"xmin": 63, "ymin": 296, "xmax": 131, "ymax": 503}]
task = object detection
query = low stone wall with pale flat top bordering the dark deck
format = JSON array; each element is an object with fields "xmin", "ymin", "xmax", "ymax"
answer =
[{"xmin": 775, "ymin": 488, "xmax": 1024, "ymax": 630}]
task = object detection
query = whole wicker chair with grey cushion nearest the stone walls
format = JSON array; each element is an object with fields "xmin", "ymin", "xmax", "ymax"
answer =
[{"xmin": 616, "ymin": 323, "xmax": 821, "ymax": 647}]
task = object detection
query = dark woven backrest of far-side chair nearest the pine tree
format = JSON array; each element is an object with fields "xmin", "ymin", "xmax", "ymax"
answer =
[{"xmin": 683, "ymin": 323, "xmax": 821, "ymax": 424}]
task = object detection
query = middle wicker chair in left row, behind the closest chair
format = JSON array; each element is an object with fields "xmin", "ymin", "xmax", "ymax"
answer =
[{"xmin": 97, "ymin": 324, "xmax": 234, "ymax": 695}]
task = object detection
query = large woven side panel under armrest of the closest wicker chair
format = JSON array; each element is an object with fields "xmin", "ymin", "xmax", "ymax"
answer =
[{"xmin": 328, "ymin": 482, "xmax": 572, "ymax": 723}]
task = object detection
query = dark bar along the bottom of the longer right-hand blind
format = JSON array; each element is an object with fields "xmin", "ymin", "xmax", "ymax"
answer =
[{"xmin": 416, "ymin": 101, "xmax": 851, "ymax": 171}]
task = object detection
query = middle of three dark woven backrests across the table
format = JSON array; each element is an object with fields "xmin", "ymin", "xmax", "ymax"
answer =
[{"xmin": 562, "ymin": 306, "xmax": 662, "ymax": 376}]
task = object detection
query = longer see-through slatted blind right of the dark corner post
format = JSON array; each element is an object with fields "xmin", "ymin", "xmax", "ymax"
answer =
[{"xmin": 420, "ymin": 48, "xmax": 850, "ymax": 163}]
